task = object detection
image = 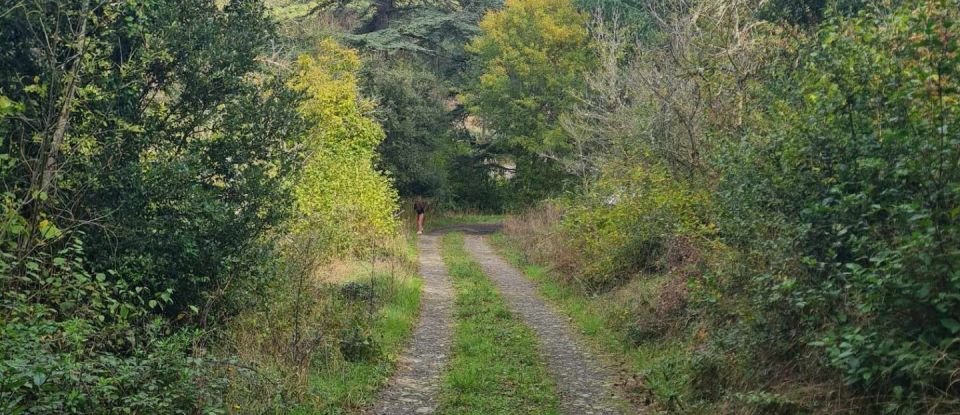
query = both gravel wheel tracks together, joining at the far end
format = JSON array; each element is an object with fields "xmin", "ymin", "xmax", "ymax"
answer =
[{"xmin": 371, "ymin": 228, "xmax": 626, "ymax": 415}]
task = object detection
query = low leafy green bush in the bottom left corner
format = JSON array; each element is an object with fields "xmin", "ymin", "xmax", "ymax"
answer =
[{"xmin": 0, "ymin": 239, "xmax": 225, "ymax": 414}]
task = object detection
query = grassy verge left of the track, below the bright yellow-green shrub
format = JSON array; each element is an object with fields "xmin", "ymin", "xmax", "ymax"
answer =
[{"xmin": 219, "ymin": 238, "xmax": 422, "ymax": 414}]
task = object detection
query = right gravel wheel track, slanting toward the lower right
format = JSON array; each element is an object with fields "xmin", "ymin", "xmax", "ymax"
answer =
[{"xmin": 465, "ymin": 235, "xmax": 621, "ymax": 415}]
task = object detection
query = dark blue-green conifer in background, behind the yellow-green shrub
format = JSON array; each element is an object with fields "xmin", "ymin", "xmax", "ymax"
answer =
[{"xmin": 273, "ymin": 0, "xmax": 501, "ymax": 210}]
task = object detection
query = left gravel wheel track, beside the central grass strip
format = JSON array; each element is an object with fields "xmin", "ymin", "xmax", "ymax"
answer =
[{"xmin": 373, "ymin": 235, "xmax": 454, "ymax": 415}]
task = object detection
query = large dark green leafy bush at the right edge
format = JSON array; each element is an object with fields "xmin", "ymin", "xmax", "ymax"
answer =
[{"xmin": 720, "ymin": 1, "xmax": 960, "ymax": 410}]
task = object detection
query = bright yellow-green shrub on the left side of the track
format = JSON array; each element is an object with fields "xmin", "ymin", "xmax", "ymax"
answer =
[{"xmin": 290, "ymin": 39, "xmax": 397, "ymax": 251}]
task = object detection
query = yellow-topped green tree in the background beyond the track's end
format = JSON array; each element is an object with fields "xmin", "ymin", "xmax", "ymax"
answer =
[{"xmin": 465, "ymin": 0, "xmax": 593, "ymax": 200}]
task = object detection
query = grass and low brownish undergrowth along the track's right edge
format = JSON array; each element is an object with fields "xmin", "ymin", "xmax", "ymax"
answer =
[{"xmin": 491, "ymin": 213, "xmax": 858, "ymax": 414}]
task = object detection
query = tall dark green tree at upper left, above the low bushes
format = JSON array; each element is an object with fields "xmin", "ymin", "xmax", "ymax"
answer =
[{"xmin": 0, "ymin": 0, "xmax": 299, "ymax": 316}]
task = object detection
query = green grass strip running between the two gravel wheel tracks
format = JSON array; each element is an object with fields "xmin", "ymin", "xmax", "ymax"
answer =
[{"xmin": 438, "ymin": 233, "xmax": 559, "ymax": 414}]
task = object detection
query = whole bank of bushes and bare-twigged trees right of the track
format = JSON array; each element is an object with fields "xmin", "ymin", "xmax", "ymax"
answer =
[{"xmin": 496, "ymin": 0, "xmax": 960, "ymax": 413}]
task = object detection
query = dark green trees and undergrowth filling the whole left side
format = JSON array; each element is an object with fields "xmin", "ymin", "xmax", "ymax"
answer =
[{"xmin": 0, "ymin": 0, "xmax": 302, "ymax": 413}]
